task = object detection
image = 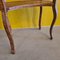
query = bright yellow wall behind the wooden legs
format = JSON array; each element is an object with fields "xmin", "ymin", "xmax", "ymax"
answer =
[{"xmin": 0, "ymin": 0, "xmax": 60, "ymax": 29}]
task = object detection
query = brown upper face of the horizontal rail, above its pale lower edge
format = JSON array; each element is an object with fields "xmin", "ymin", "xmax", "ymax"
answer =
[{"xmin": 7, "ymin": 1, "xmax": 52, "ymax": 7}]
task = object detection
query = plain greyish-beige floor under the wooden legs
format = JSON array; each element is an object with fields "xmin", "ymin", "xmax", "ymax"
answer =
[{"xmin": 0, "ymin": 27, "xmax": 60, "ymax": 60}]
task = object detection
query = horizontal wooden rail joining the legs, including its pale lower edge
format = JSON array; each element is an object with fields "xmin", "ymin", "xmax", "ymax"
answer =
[{"xmin": 0, "ymin": 0, "xmax": 53, "ymax": 9}]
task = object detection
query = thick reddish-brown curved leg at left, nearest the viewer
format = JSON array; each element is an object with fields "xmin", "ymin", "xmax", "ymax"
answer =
[{"xmin": 2, "ymin": 11, "xmax": 15, "ymax": 54}]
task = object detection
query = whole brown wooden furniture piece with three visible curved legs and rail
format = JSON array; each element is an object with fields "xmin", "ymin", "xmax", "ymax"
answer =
[{"xmin": 0, "ymin": 0, "xmax": 57, "ymax": 54}]
